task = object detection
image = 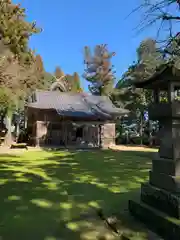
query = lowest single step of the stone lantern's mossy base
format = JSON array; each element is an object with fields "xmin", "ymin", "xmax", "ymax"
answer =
[{"xmin": 129, "ymin": 200, "xmax": 180, "ymax": 240}]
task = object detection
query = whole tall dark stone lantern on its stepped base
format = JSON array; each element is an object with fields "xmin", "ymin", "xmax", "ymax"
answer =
[{"xmin": 129, "ymin": 64, "xmax": 180, "ymax": 240}]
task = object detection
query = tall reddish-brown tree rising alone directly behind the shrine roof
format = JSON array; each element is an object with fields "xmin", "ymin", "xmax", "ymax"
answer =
[{"xmin": 83, "ymin": 44, "xmax": 115, "ymax": 96}]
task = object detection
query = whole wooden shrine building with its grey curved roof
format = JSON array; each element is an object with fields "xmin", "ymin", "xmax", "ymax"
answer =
[{"xmin": 27, "ymin": 91, "xmax": 128, "ymax": 149}]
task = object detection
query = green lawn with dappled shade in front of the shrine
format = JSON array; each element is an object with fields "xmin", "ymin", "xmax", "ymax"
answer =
[{"xmin": 0, "ymin": 150, "xmax": 157, "ymax": 240}]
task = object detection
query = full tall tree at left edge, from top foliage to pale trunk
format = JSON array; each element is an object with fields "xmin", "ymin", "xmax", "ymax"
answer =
[{"xmin": 0, "ymin": 0, "xmax": 40, "ymax": 142}]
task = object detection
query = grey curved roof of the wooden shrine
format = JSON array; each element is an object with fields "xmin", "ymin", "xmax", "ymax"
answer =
[{"xmin": 28, "ymin": 90, "xmax": 128, "ymax": 119}]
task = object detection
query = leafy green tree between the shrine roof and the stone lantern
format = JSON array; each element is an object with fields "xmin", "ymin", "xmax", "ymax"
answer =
[{"xmin": 113, "ymin": 39, "xmax": 165, "ymax": 111}]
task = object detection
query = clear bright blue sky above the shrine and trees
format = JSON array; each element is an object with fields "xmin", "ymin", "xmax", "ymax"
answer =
[{"xmin": 14, "ymin": 0, "xmax": 162, "ymax": 90}]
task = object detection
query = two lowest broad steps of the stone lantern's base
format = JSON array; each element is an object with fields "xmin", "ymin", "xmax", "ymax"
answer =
[{"xmin": 129, "ymin": 182, "xmax": 180, "ymax": 240}]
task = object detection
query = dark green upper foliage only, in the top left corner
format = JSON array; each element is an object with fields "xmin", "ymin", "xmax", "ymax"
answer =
[{"xmin": 0, "ymin": 0, "xmax": 40, "ymax": 62}]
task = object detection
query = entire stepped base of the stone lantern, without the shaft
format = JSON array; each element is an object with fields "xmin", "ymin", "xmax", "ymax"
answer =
[{"xmin": 129, "ymin": 152, "xmax": 180, "ymax": 240}]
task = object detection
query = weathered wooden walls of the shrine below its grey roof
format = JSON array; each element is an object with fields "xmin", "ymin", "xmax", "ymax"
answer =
[{"xmin": 27, "ymin": 109, "xmax": 115, "ymax": 148}]
